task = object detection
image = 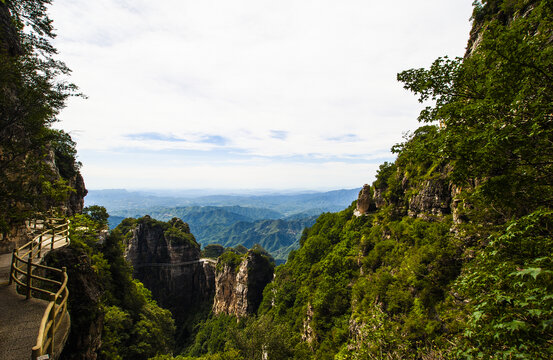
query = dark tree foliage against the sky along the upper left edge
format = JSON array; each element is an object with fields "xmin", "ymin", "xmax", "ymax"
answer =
[{"xmin": 0, "ymin": 0, "xmax": 79, "ymax": 231}]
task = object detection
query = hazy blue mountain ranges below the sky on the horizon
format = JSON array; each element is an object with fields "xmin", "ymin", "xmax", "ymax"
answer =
[{"xmin": 85, "ymin": 189, "xmax": 360, "ymax": 262}]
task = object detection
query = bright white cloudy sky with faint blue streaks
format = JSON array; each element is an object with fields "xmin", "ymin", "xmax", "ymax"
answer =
[{"xmin": 50, "ymin": 0, "xmax": 472, "ymax": 190}]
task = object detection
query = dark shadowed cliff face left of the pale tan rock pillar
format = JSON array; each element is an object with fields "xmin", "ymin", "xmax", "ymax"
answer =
[{"xmin": 125, "ymin": 216, "xmax": 215, "ymax": 318}]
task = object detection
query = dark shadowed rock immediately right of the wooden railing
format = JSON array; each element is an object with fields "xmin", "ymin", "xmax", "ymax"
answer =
[{"xmin": 44, "ymin": 247, "xmax": 104, "ymax": 360}]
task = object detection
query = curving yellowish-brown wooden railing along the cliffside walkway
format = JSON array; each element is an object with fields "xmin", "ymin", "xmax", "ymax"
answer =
[{"xmin": 10, "ymin": 219, "xmax": 69, "ymax": 359}]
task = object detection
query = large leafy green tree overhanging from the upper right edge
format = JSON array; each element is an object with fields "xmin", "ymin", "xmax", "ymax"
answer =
[{"xmin": 398, "ymin": 1, "xmax": 553, "ymax": 221}]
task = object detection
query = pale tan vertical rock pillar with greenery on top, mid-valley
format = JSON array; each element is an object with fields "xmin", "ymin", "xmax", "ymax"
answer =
[{"xmin": 213, "ymin": 250, "xmax": 274, "ymax": 317}]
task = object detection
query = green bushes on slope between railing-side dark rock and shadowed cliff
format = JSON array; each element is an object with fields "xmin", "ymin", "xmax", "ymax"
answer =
[{"xmin": 67, "ymin": 212, "xmax": 175, "ymax": 359}]
